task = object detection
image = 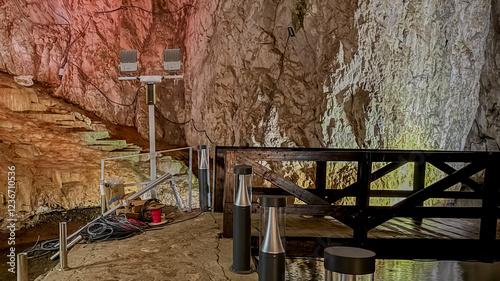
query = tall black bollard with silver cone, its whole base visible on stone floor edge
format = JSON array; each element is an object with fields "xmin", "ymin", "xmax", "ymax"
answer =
[{"xmin": 230, "ymin": 165, "xmax": 252, "ymax": 274}]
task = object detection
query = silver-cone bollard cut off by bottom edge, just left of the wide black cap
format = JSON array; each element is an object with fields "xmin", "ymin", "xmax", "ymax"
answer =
[{"xmin": 259, "ymin": 196, "xmax": 286, "ymax": 281}]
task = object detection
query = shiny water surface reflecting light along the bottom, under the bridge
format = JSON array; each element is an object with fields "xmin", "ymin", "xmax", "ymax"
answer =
[{"xmin": 286, "ymin": 258, "xmax": 500, "ymax": 281}]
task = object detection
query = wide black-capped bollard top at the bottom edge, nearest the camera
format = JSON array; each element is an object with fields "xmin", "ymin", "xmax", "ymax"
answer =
[{"xmin": 325, "ymin": 247, "xmax": 375, "ymax": 281}]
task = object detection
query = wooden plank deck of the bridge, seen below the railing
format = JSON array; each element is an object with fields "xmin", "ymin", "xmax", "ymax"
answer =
[{"xmin": 243, "ymin": 214, "xmax": 500, "ymax": 260}]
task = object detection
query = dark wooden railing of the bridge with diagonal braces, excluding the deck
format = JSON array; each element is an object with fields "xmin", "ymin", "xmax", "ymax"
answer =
[{"xmin": 214, "ymin": 147, "xmax": 500, "ymax": 260}]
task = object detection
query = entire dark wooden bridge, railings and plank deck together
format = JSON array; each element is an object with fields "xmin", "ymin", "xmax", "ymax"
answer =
[{"xmin": 213, "ymin": 147, "xmax": 500, "ymax": 262}]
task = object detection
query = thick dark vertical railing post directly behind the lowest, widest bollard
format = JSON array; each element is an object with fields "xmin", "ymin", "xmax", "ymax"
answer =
[{"xmin": 353, "ymin": 152, "xmax": 372, "ymax": 247}]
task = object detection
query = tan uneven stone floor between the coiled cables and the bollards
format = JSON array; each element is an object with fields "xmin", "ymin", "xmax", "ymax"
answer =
[{"xmin": 36, "ymin": 211, "xmax": 258, "ymax": 281}]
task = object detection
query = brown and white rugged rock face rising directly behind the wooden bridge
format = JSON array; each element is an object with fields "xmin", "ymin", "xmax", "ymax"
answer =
[{"xmin": 188, "ymin": 0, "xmax": 490, "ymax": 150}]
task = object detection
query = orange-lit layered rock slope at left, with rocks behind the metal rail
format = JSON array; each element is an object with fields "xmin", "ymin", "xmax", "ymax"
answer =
[{"xmin": 0, "ymin": 74, "xmax": 192, "ymax": 229}]
